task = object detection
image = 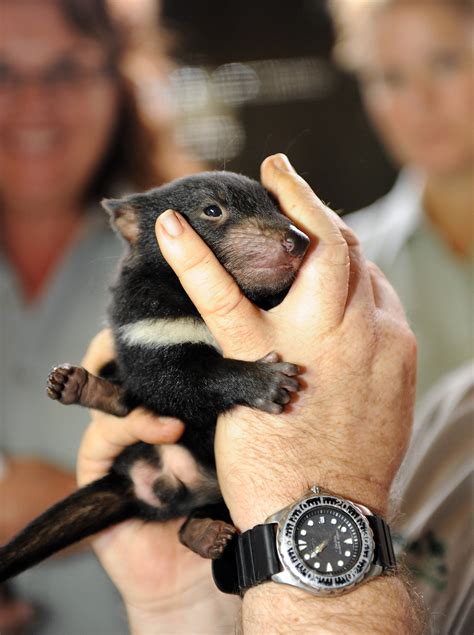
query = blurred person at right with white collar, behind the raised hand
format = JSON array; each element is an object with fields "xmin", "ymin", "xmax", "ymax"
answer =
[{"xmin": 330, "ymin": 0, "xmax": 474, "ymax": 397}]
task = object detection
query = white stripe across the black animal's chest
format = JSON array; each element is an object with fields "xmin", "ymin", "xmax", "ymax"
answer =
[{"xmin": 119, "ymin": 317, "xmax": 220, "ymax": 352}]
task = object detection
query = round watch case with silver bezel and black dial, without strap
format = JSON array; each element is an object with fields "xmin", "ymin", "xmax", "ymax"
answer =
[{"xmin": 279, "ymin": 495, "xmax": 374, "ymax": 592}]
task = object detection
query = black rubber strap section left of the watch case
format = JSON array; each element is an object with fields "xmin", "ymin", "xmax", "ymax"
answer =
[{"xmin": 212, "ymin": 523, "xmax": 281, "ymax": 594}]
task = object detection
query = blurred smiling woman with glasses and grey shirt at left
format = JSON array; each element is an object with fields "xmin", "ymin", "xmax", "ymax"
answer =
[{"xmin": 0, "ymin": 0, "xmax": 197, "ymax": 635}]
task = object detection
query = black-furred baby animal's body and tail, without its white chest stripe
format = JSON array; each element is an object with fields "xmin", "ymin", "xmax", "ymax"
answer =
[{"xmin": 0, "ymin": 172, "xmax": 308, "ymax": 581}]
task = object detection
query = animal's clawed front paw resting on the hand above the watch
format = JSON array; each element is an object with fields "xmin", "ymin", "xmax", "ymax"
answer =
[{"xmin": 249, "ymin": 352, "xmax": 301, "ymax": 414}]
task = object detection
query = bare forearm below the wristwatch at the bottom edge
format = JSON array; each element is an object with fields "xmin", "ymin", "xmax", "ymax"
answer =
[{"xmin": 242, "ymin": 575, "xmax": 423, "ymax": 635}]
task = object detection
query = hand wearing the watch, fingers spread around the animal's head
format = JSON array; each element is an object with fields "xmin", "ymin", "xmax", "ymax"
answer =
[{"xmin": 156, "ymin": 155, "xmax": 416, "ymax": 530}]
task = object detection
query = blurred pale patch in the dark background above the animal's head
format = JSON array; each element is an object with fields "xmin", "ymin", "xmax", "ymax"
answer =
[{"xmin": 170, "ymin": 57, "xmax": 336, "ymax": 161}]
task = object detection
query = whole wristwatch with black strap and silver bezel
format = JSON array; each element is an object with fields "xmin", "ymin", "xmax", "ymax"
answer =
[{"xmin": 212, "ymin": 486, "xmax": 396, "ymax": 596}]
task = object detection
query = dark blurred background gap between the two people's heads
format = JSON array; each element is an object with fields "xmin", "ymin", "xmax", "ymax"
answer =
[{"xmin": 162, "ymin": 0, "xmax": 395, "ymax": 211}]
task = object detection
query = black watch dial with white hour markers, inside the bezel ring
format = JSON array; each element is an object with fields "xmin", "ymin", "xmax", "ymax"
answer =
[{"xmin": 294, "ymin": 506, "xmax": 362, "ymax": 576}]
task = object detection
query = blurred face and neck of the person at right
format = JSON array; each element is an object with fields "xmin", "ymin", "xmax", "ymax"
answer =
[{"xmin": 334, "ymin": 0, "xmax": 474, "ymax": 260}]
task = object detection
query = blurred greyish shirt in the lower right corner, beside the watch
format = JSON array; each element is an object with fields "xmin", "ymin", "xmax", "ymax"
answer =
[{"xmin": 393, "ymin": 361, "xmax": 474, "ymax": 635}]
